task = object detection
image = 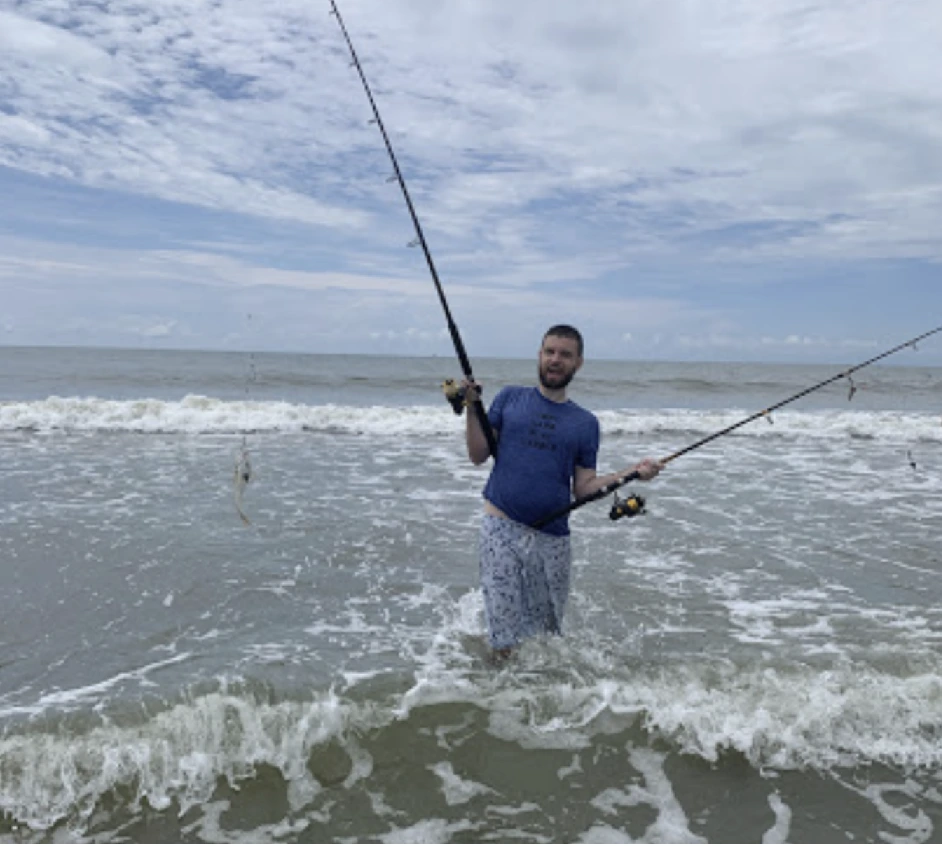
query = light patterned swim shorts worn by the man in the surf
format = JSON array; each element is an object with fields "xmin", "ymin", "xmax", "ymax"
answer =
[{"xmin": 480, "ymin": 514, "xmax": 571, "ymax": 649}]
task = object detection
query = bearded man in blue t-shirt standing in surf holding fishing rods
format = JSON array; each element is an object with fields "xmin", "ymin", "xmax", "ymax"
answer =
[{"xmin": 464, "ymin": 325, "xmax": 662, "ymax": 658}]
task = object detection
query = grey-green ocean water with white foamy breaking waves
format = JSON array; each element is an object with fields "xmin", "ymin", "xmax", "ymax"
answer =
[{"xmin": 0, "ymin": 348, "xmax": 942, "ymax": 843}]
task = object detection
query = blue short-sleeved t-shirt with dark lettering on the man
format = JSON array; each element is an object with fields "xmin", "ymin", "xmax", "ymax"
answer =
[{"xmin": 484, "ymin": 387, "xmax": 600, "ymax": 535}]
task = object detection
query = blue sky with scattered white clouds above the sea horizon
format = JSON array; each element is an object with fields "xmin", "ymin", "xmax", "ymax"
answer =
[{"xmin": 0, "ymin": 0, "xmax": 942, "ymax": 365}]
